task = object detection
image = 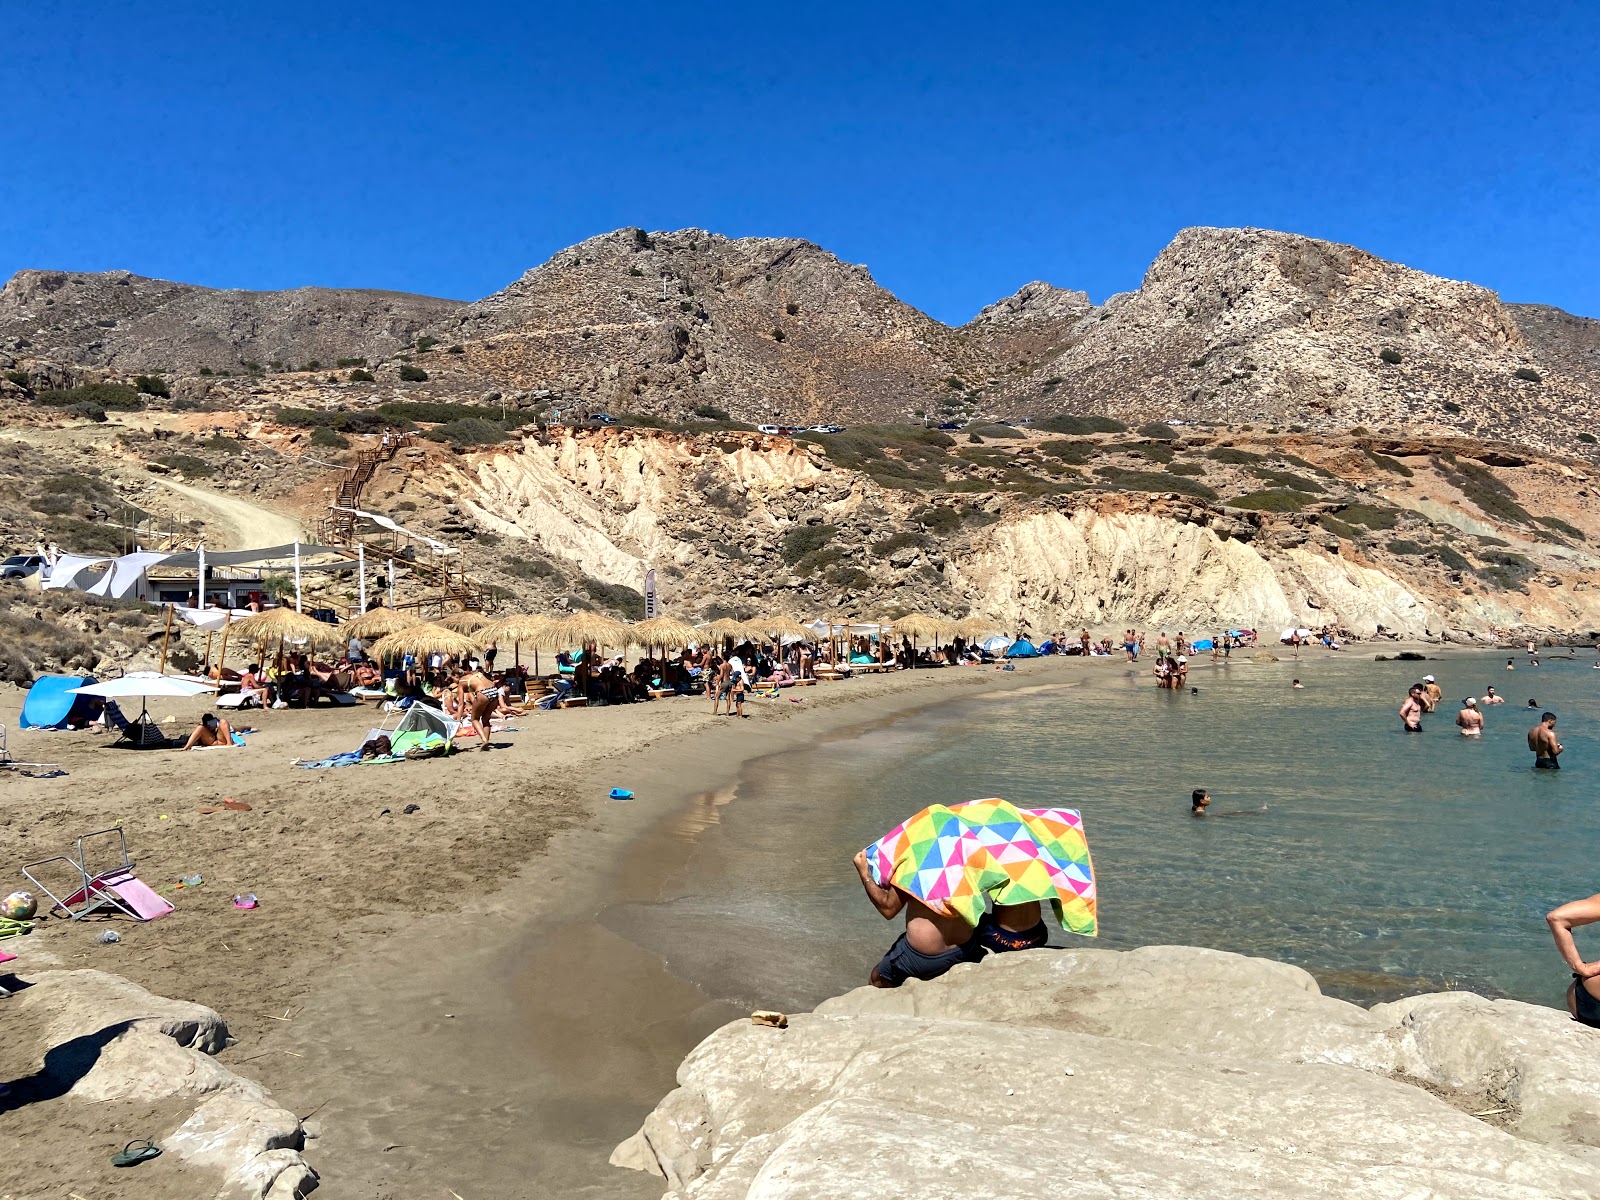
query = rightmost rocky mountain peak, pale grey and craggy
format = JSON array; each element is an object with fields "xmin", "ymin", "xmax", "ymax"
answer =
[{"xmin": 1008, "ymin": 229, "xmax": 1600, "ymax": 448}]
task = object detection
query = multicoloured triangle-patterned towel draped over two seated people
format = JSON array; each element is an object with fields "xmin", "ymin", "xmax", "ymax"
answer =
[{"xmin": 867, "ymin": 798, "xmax": 1099, "ymax": 938}]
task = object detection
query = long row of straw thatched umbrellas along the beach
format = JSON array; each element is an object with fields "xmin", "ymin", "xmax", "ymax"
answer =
[{"xmin": 208, "ymin": 608, "xmax": 998, "ymax": 672}]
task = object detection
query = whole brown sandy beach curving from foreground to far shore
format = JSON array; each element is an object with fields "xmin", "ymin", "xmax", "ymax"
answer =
[{"xmin": 0, "ymin": 659, "xmax": 1145, "ymax": 1200}]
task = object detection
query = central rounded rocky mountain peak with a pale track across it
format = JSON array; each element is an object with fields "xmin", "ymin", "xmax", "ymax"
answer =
[{"xmin": 429, "ymin": 229, "xmax": 987, "ymax": 422}]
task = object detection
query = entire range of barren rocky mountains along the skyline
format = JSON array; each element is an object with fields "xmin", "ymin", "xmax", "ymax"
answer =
[{"xmin": 0, "ymin": 229, "xmax": 1600, "ymax": 453}]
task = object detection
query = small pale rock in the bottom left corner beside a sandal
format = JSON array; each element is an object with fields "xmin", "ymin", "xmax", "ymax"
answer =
[{"xmin": 5, "ymin": 971, "xmax": 317, "ymax": 1200}]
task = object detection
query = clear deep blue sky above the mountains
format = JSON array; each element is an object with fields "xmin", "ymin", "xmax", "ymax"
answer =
[{"xmin": 0, "ymin": 0, "xmax": 1600, "ymax": 322}]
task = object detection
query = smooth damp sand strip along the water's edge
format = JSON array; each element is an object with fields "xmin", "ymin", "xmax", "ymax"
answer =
[{"xmin": 246, "ymin": 659, "xmax": 1088, "ymax": 1197}]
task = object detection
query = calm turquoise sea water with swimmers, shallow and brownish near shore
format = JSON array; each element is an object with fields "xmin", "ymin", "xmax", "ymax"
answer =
[{"xmin": 600, "ymin": 651, "xmax": 1600, "ymax": 1008}]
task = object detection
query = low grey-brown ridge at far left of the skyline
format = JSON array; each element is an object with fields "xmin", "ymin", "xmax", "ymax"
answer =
[{"xmin": 0, "ymin": 270, "xmax": 462, "ymax": 374}]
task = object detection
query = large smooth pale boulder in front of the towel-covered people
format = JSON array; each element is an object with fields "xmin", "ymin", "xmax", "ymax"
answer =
[{"xmin": 613, "ymin": 947, "xmax": 1600, "ymax": 1200}]
